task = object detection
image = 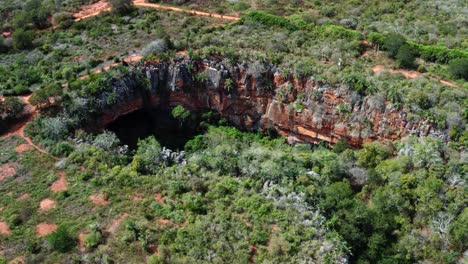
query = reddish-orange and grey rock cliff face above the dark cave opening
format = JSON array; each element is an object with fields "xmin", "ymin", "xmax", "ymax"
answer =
[{"xmin": 102, "ymin": 57, "xmax": 438, "ymax": 146}]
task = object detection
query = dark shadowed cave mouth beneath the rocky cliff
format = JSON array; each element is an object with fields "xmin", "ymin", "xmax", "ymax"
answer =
[{"xmin": 107, "ymin": 109, "xmax": 200, "ymax": 150}]
